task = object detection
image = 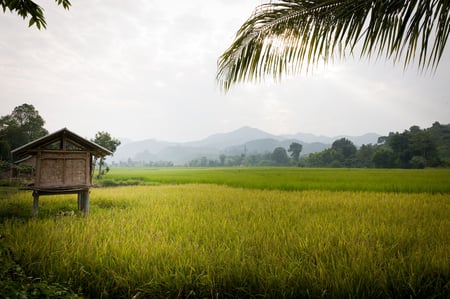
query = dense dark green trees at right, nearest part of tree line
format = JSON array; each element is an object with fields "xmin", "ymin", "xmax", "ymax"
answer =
[{"xmin": 301, "ymin": 122, "xmax": 450, "ymax": 168}]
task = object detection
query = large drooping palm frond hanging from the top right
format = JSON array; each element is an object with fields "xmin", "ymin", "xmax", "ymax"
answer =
[{"xmin": 216, "ymin": 0, "xmax": 450, "ymax": 91}]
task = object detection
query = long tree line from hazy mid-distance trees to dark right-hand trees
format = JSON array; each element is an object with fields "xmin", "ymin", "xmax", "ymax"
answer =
[{"xmin": 186, "ymin": 122, "xmax": 450, "ymax": 168}]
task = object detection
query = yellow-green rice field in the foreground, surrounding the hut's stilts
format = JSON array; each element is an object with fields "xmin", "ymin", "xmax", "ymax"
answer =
[{"xmin": 0, "ymin": 169, "xmax": 450, "ymax": 298}]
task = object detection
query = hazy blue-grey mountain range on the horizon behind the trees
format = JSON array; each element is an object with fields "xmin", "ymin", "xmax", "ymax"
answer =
[{"xmin": 108, "ymin": 127, "xmax": 380, "ymax": 165}]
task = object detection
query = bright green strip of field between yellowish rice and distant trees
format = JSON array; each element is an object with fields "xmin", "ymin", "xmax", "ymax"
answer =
[{"xmin": 97, "ymin": 167, "xmax": 450, "ymax": 193}]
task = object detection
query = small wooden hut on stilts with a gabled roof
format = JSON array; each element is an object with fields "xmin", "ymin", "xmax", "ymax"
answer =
[{"xmin": 11, "ymin": 128, "xmax": 112, "ymax": 216}]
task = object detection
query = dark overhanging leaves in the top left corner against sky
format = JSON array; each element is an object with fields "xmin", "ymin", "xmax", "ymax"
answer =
[{"xmin": 0, "ymin": 0, "xmax": 71, "ymax": 29}]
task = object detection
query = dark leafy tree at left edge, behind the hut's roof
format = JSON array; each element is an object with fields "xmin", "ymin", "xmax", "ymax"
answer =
[{"xmin": 0, "ymin": 104, "xmax": 48, "ymax": 160}]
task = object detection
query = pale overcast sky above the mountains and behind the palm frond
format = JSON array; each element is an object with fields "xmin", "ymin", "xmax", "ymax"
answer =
[{"xmin": 0, "ymin": 0, "xmax": 450, "ymax": 141}]
